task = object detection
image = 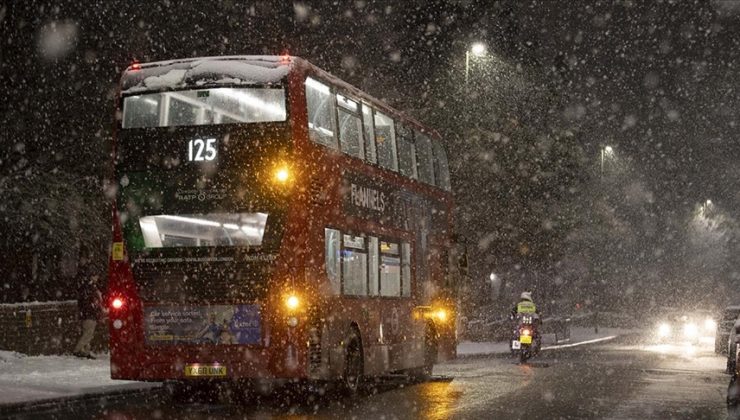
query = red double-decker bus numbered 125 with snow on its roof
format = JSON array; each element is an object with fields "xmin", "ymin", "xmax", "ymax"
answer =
[{"xmin": 109, "ymin": 56, "xmax": 456, "ymax": 390}]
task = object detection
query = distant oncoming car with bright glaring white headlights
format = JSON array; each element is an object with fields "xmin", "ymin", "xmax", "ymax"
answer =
[{"xmin": 655, "ymin": 311, "xmax": 717, "ymax": 342}]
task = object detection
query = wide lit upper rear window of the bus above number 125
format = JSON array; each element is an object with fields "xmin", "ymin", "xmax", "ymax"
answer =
[{"xmin": 122, "ymin": 87, "xmax": 287, "ymax": 129}]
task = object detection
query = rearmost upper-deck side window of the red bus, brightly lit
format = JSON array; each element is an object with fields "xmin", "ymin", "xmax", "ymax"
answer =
[{"xmin": 306, "ymin": 77, "xmax": 337, "ymax": 149}]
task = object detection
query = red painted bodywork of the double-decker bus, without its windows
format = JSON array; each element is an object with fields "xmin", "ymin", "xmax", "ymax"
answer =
[{"xmin": 108, "ymin": 57, "xmax": 456, "ymax": 381}]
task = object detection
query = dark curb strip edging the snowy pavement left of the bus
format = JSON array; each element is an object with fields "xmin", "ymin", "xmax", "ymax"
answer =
[{"xmin": 0, "ymin": 387, "xmax": 164, "ymax": 418}]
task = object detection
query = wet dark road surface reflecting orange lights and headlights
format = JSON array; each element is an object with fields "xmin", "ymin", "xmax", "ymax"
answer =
[{"xmin": 14, "ymin": 337, "xmax": 729, "ymax": 420}]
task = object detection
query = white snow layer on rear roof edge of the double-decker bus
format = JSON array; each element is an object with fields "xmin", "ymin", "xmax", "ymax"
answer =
[{"xmin": 121, "ymin": 55, "xmax": 292, "ymax": 94}]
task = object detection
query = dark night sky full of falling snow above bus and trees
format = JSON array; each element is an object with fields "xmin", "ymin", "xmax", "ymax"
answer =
[{"xmin": 0, "ymin": 0, "xmax": 740, "ymax": 306}]
